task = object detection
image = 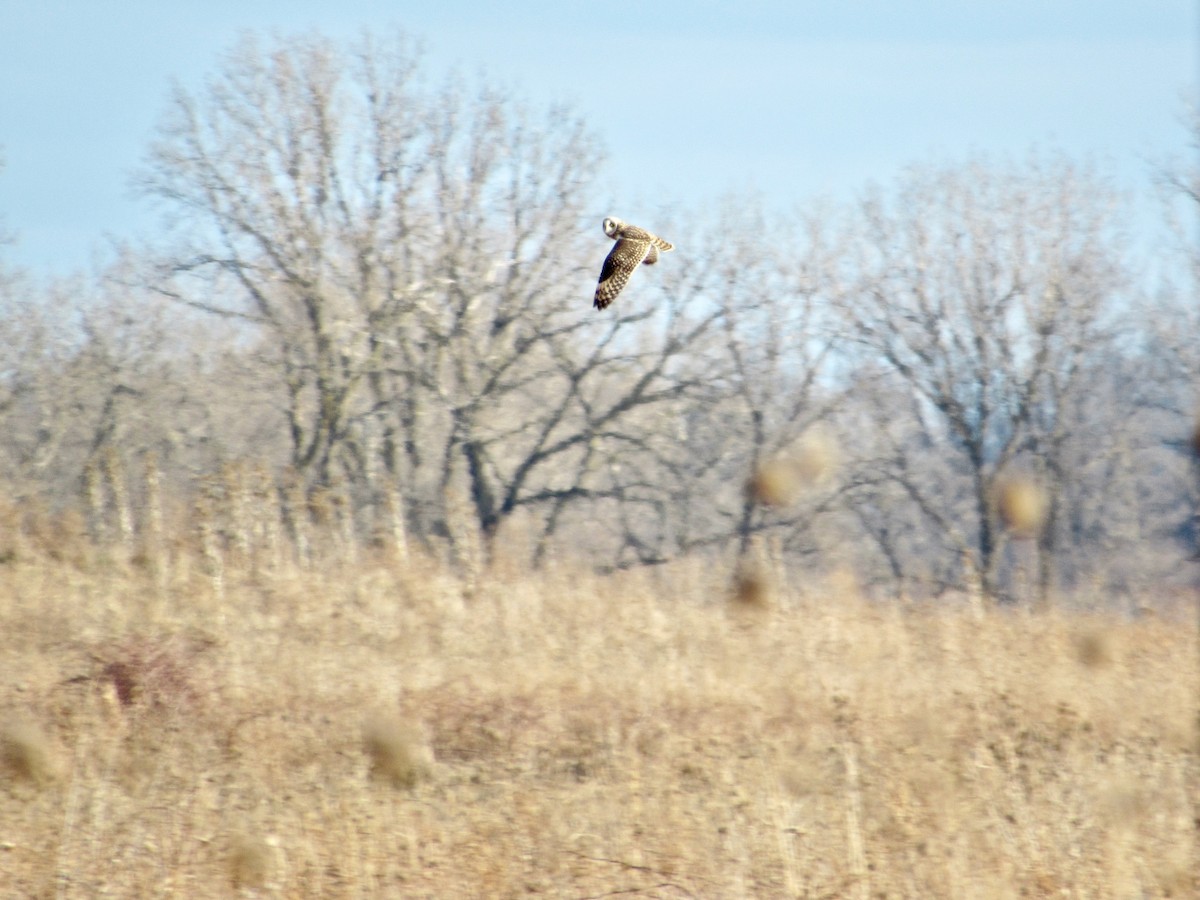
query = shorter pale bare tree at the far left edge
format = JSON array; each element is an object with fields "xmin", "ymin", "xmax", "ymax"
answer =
[{"xmin": 0, "ymin": 254, "xmax": 256, "ymax": 554}]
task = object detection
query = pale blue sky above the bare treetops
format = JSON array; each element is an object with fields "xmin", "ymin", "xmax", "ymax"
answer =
[{"xmin": 0, "ymin": 0, "xmax": 1198, "ymax": 272}]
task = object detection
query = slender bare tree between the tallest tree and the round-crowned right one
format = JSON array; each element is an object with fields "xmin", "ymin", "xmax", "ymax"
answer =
[{"xmin": 619, "ymin": 198, "xmax": 840, "ymax": 571}]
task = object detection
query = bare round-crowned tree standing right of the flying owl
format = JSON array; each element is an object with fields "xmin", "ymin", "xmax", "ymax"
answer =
[{"xmin": 839, "ymin": 161, "xmax": 1127, "ymax": 607}]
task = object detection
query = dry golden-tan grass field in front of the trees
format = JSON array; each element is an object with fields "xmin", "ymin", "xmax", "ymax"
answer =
[{"xmin": 0, "ymin": 528, "xmax": 1200, "ymax": 899}]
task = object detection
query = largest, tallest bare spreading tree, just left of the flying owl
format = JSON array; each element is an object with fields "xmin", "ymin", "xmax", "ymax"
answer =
[{"xmin": 133, "ymin": 36, "xmax": 729, "ymax": 566}]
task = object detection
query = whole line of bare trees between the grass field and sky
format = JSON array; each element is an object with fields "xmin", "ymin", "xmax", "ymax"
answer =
[{"xmin": 0, "ymin": 35, "xmax": 1200, "ymax": 607}]
